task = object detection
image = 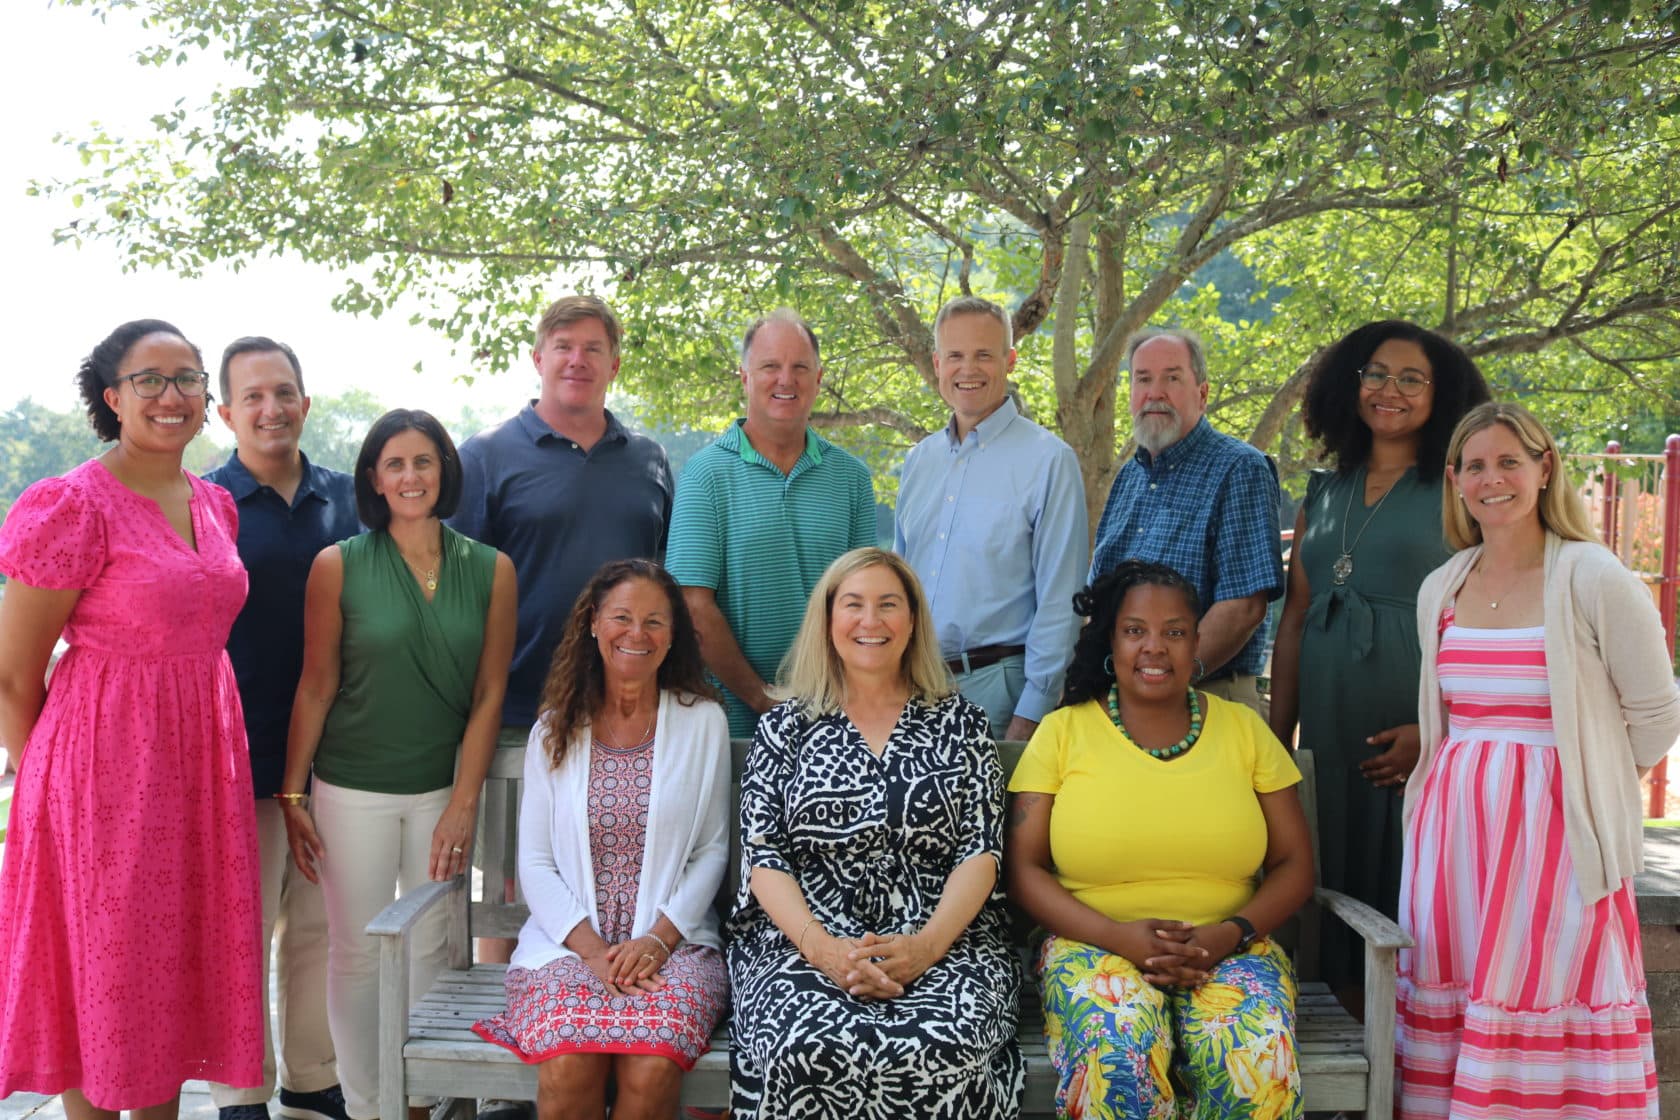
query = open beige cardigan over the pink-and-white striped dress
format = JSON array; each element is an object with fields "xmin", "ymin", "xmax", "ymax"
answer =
[{"xmin": 1403, "ymin": 532, "xmax": 1680, "ymax": 903}]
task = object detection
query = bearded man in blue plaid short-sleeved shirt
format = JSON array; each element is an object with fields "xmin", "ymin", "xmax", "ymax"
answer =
[{"xmin": 1090, "ymin": 329, "xmax": 1284, "ymax": 715}]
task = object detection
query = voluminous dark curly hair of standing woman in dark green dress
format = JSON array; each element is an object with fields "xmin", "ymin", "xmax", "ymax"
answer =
[{"xmin": 1300, "ymin": 319, "xmax": 1488, "ymax": 482}]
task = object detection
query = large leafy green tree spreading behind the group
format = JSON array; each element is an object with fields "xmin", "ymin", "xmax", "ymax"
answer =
[{"xmin": 42, "ymin": 0, "xmax": 1680, "ymax": 517}]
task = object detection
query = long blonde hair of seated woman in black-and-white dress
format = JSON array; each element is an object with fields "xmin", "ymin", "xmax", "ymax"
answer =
[{"xmin": 771, "ymin": 547, "xmax": 956, "ymax": 715}]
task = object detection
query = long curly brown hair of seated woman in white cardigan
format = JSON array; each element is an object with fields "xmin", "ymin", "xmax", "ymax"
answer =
[{"xmin": 538, "ymin": 559, "xmax": 717, "ymax": 769}]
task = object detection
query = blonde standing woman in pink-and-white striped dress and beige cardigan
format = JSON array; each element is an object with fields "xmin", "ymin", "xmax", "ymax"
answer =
[{"xmin": 1398, "ymin": 403, "xmax": 1680, "ymax": 1120}]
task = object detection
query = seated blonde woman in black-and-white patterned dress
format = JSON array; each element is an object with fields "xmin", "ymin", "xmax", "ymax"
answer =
[{"xmin": 727, "ymin": 549, "xmax": 1021, "ymax": 1120}]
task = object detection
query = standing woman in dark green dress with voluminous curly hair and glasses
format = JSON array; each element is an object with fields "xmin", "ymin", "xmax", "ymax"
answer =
[{"xmin": 1272, "ymin": 319, "xmax": 1488, "ymax": 1009}]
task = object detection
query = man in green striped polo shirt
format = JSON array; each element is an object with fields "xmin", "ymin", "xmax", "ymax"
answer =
[{"xmin": 665, "ymin": 309, "xmax": 875, "ymax": 739}]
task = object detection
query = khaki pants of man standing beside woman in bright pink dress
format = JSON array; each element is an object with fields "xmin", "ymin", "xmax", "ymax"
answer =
[{"xmin": 210, "ymin": 798, "xmax": 338, "ymax": 1108}]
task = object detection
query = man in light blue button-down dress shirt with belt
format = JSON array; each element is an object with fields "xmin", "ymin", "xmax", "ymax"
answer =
[{"xmin": 894, "ymin": 296, "xmax": 1090, "ymax": 739}]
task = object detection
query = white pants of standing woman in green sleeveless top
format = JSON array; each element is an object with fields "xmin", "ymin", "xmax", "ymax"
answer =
[{"xmin": 311, "ymin": 777, "xmax": 450, "ymax": 1120}]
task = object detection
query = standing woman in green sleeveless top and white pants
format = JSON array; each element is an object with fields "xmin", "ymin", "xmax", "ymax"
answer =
[{"xmin": 276, "ymin": 408, "xmax": 516, "ymax": 1120}]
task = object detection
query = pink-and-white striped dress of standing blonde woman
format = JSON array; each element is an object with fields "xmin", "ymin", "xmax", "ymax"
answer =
[{"xmin": 1396, "ymin": 610, "xmax": 1656, "ymax": 1120}]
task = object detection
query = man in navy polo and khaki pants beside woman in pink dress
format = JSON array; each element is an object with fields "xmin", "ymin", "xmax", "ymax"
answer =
[{"xmin": 205, "ymin": 338, "xmax": 361, "ymax": 1120}]
